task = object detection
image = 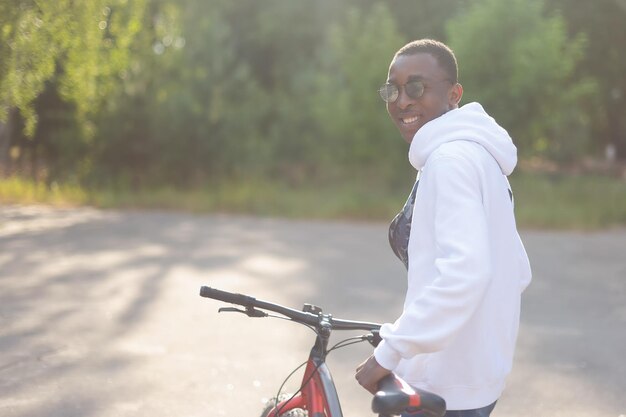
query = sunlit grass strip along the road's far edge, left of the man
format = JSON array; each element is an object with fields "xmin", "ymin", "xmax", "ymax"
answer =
[{"xmin": 0, "ymin": 177, "xmax": 405, "ymax": 220}]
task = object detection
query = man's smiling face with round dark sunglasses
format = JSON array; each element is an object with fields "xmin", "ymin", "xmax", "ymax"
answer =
[{"xmin": 387, "ymin": 53, "xmax": 463, "ymax": 143}]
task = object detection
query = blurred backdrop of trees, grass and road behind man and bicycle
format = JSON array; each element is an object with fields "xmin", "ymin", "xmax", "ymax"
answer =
[{"xmin": 0, "ymin": 0, "xmax": 626, "ymax": 417}]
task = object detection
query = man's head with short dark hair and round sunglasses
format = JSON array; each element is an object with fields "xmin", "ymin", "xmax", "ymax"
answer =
[{"xmin": 380, "ymin": 39, "xmax": 463, "ymax": 143}]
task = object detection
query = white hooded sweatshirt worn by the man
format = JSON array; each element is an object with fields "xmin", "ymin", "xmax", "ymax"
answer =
[{"xmin": 374, "ymin": 103, "xmax": 531, "ymax": 410}]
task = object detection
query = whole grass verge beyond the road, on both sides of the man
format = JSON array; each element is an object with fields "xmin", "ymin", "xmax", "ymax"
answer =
[{"xmin": 0, "ymin": 172, "xmax": 626, "ymax": 230}]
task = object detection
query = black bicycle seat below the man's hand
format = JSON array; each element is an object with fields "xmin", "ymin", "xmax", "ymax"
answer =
[{"xmin": 372, "ymin": 374, "xmax": 446, "ymax": 417}]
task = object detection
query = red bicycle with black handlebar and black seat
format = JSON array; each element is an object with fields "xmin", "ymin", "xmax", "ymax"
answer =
[{"xmin": 200, "ymin": 286, "xmax": 446, "ymax": 417}]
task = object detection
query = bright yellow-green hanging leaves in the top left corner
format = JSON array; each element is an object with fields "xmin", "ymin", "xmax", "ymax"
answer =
[{"xmin": 0, "ymin": 0, "xmax": 144, "ymax": 137}]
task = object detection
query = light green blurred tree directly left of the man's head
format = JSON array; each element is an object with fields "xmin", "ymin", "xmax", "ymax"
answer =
[{"xmin": 308, "ymin": 4, "xmax": 408, "ymax": 179}]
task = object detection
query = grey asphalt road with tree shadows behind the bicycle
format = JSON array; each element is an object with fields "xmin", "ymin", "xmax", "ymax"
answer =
[{"xmin": 0, "ymin": 206, "xmax": 626, "ymax": 417}]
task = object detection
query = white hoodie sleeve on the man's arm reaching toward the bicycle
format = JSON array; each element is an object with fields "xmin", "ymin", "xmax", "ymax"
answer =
[{"xmin": 374, "ymin": 155, "xmax": 490, "ymax": 370}]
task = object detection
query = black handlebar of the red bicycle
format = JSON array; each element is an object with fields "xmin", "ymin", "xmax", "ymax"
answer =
[{"xmin": 200, "ymin": 286, "xmax": 380, "ymax": 330}]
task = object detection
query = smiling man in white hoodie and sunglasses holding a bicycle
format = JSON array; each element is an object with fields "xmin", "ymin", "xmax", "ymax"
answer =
[{"xmin": 356, "ymin": 39, "xmax": 531, "ymax": 417}]
